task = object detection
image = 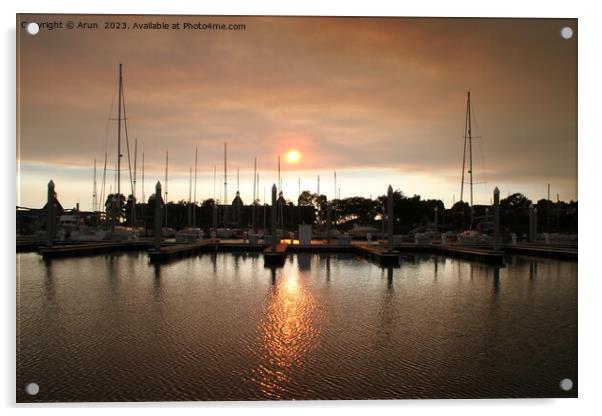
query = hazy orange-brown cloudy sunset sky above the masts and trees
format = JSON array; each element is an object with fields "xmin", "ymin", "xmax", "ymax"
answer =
[{"xmin": 17, "ymin": 15, "xmax": 577, "ymax": 209}]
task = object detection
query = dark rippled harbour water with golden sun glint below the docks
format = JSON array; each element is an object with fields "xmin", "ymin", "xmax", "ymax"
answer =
[{"xmin": 17, "ymin": 253, "xmax": 577, "ymax": 401}]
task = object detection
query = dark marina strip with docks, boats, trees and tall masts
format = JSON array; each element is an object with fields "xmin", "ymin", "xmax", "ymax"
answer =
[{"xmin": 17, "ymin": 64, "xmax": 577, "ymax": 265}]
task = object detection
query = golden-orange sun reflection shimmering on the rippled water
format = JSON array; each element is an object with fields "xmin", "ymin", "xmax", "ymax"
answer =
[{"xmin": 248, "ymin": 269, "xmax": 322, "ymax": 398}]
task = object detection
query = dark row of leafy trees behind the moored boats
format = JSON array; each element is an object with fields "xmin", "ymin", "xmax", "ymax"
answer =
[{"xmin": 99, "ymin": 190, "xmax": 578, "ymax": 234}]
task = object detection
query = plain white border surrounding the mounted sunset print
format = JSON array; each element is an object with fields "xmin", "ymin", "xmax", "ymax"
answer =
[{"xmin": 0, "ymin": 0, "xmax": 602, "ymax": 416}]
